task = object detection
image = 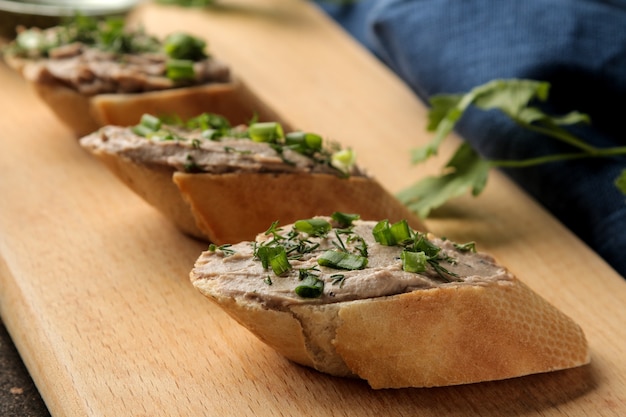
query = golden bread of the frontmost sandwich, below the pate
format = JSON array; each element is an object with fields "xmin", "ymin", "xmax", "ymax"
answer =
[{"xmin": 191, "ymin": 273, "xmax": 590, "ymax": 389}]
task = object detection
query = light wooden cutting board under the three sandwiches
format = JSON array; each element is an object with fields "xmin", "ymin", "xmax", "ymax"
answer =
[{"xmin": 0, "ymin": 0, "xmax": 626, "ymax": 417}]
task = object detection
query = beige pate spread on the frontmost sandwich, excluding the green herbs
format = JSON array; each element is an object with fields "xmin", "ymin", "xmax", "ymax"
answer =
[{"xmin": 192, "ymin": 216, "xmax": 512, "ymax": 309}]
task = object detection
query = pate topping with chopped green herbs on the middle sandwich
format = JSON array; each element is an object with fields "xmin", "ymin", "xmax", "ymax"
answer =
[{"xmin": 80, "ymin": 113, "xmax": 363, "ymax": 176}]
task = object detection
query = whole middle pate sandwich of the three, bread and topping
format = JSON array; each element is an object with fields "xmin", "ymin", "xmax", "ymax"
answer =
[{"xmin": 80, "ymin": 113, "xmax": 424, "ymax": 244}]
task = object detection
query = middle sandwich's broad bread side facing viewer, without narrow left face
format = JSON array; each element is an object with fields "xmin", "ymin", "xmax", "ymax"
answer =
[{"xmin": 173, "ymin": 172, "xmax": 426, "ymax": 244}]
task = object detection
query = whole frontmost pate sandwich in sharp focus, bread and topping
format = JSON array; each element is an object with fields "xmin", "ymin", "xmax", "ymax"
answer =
[{"xmin": 190, "ymin": 213, "xmax": 590, "ymax": 388}]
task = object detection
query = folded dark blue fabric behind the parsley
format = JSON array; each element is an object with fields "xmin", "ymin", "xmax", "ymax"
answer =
[{"xmin": 320, "ymin": 0, "xmax": 626, "ymax": 277}]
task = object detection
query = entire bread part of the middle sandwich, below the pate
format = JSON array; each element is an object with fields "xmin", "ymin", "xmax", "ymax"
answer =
[{"xmin": 83, "ymin": 142, "xmax": 426, "ymax": 245}]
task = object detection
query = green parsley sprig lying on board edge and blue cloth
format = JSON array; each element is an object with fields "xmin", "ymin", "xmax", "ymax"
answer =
[{"xmin": 397, "ymin": 79, "xmax": 626, "ymax": 218}]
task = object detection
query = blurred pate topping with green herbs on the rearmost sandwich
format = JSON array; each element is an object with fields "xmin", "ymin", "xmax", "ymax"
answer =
[{"xmin": 5, "ymin": 16, "xmax": 230, "ymax": 96}]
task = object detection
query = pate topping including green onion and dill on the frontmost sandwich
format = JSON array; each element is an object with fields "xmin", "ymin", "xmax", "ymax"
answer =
[{"xmin": 192, "ymin": 213, "xmax": 512, "ymax": 308}]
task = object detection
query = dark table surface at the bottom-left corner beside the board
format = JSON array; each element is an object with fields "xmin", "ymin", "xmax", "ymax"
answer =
[{"xmin": 0, "ymin": 320, "xmax": 50, "ymax": 417}]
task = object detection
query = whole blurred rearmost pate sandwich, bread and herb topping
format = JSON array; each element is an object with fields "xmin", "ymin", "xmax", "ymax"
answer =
[{"xmin": 3, "ymin": 16, "xmax": 279, "ymax": 136}]
